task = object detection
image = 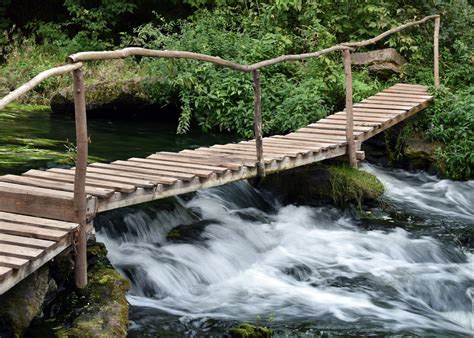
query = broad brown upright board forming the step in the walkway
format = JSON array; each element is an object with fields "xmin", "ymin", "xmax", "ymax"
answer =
[{"xmin": 0, "ymin": 182, "xmax": 77, "ymax": 221}]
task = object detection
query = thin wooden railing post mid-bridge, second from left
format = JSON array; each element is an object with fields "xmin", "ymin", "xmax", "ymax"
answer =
[{"xmin": 252, "ymin": 69, "xmax": 265, "ymax": 180}]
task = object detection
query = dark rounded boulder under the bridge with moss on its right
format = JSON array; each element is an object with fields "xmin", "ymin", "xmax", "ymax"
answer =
[{"xmin": 260, "ymin": 164, "xmax": 384, "ymax": 207}]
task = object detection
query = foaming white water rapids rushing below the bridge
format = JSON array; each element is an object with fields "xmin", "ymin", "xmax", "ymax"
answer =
[{"xmin": 97, "ymin": 166, "xmax": 474, "ymax": 336}]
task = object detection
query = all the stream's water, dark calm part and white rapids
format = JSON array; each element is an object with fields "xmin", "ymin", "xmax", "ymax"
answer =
[{"xmin": 0, "ymin": 106, "xmax": 474, "ymax": 337}]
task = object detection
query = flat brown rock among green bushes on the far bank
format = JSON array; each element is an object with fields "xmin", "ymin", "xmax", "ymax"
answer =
[{"xmin": 351, "ymin": 48, "xmax": 407, "ymax": 78}]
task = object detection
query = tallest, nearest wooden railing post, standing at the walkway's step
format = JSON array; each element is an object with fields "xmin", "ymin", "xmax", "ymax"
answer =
[{"xmin": 72, "ymin": 68, "xmax": 88, "ymax": 289}]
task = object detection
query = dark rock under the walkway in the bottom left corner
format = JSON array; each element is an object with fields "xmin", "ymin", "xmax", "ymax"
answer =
[{"xmin": 0, "ymin": 266, "xmax": 50, "ymax": 337}]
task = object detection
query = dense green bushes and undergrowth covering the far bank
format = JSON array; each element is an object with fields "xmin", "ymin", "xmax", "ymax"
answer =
[{"xmin": 0, "ymin": 0, "xmax": 474, "ymax": 179}]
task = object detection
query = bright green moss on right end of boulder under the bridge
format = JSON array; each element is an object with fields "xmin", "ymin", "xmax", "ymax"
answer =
[{"xmin": 327, "ymin": 165, "xmax": 384, "ymax": 208}]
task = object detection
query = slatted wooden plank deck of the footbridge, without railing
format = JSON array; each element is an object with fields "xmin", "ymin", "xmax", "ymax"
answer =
[{"xmin": 0, "ymin": 83, "xmax": 432, "ymax": 294}]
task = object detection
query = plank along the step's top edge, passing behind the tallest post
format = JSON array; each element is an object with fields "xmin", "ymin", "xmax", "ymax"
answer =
[{"xmin": 0, "ymin": 175, "xmax": 114, "ymax": 197}]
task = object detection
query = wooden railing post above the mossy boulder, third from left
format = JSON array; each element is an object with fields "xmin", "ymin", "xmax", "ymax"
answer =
[{"xmin": 342, "ymin": 49, "xmax": 357, "ymax": 168}]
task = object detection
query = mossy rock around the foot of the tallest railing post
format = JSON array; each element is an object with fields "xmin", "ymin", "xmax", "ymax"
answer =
[{"xmin": 27, "ymin": 243, "xmax": 130, "ymax": 337}]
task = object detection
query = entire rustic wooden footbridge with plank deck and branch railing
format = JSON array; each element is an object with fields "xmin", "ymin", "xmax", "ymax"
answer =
[{"xmin": 0, "ymin": 16, "xmax": 440, "ymax": 294}]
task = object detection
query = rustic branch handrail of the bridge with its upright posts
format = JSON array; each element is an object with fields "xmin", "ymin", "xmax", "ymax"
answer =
[{"xmin": 0, "ymin": 15, "xmax": 440, "ymax": 288}]
